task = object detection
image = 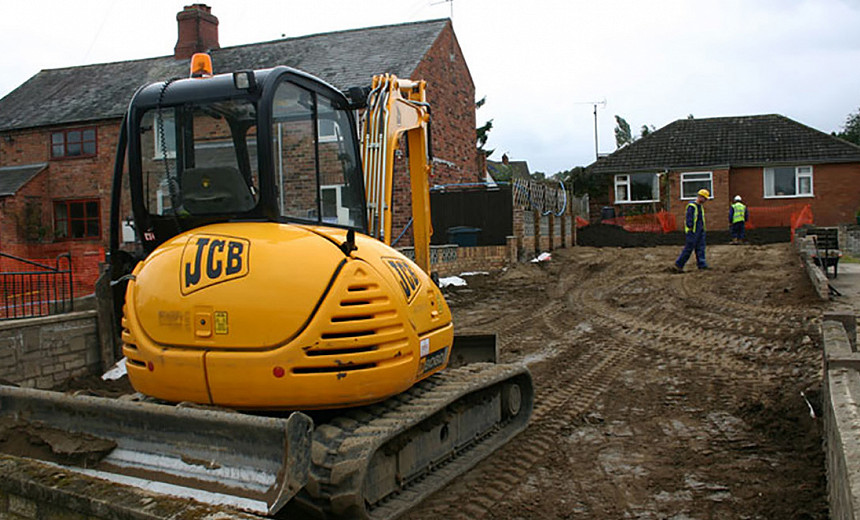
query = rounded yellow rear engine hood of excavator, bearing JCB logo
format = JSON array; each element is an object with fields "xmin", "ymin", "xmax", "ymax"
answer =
[{"xmin": 127, "ymin": 222, "xmax": 345, "ymax": 350}]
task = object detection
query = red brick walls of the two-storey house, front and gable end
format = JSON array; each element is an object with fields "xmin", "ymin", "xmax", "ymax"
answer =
[{"xmin": 0, "ymin": 20, "xmax": 483, "ymax": 274}]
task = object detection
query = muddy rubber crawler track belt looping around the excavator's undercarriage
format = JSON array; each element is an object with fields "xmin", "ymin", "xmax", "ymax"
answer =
[{"xmin": 290, "ymin": 364, "xmax": 533, "ymax": 520}]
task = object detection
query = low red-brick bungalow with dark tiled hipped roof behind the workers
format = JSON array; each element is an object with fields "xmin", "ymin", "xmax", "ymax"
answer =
[{"xmin": 589, "ymin": 114, "xmax": 860, "ymax": 229}]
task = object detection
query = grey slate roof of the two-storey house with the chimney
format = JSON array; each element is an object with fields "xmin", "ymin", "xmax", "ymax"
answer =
[{"xmin": 0, "ymin": 19, "xmax": 449, "ymax": 131}]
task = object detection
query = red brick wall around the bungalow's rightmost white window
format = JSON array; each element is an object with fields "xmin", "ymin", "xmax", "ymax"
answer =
[{"xmin": 731, "ymin": 163, "xmax": 860, "ymax": 226}]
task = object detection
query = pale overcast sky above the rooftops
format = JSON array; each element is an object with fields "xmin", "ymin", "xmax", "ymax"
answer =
[{"xmin": 0, "ymin": 0, "xmax": 860, "ymax": 174}]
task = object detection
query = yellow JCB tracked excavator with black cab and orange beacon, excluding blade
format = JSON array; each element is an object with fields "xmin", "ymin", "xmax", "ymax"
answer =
[{"xmin": 0, "ymin": 56, "xmax": 533, "ymax": 518}]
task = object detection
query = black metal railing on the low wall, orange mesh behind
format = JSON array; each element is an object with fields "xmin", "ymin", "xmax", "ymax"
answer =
[{"xmin": 0, "ymin": 253, "xmax": 75, "ymax": 320}]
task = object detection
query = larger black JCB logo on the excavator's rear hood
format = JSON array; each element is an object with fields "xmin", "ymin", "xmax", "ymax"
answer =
[{"xmin": 179, "ymin": 235, "xmax": 251, "ymax": 294}]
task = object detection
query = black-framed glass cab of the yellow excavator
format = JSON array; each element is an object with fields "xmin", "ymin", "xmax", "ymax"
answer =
[{"xmin": 112, "ymin": 67, "xmax": 366, "ymax": 256}]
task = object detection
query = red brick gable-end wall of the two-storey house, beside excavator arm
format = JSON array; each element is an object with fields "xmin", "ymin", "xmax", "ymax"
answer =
[{"xmin": 392, "ymin": 23, "xmax": 483, "ymax": 246}]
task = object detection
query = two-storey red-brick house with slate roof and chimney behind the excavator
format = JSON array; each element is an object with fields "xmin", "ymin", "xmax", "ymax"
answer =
[{"xmin": 0, "ymin": 4, "xmax": 484, "ymax": 292}]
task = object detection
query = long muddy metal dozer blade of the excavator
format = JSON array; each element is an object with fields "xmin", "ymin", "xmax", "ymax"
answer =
[{"xmin": 0, "ymin": 386, "xmax": 313, "ymax": 515}]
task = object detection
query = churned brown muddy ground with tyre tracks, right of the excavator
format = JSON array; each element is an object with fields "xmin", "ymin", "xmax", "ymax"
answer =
[{"xmin": 408, "ymin": 243, "xmax": 828, "ymax": 520}]
